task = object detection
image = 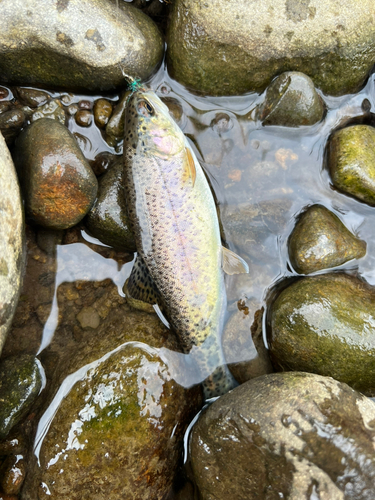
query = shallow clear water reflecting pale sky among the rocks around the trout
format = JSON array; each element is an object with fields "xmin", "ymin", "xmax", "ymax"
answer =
[{"xmin": 5, "ymin": 60, "xmax": 375, "ymax": 498}]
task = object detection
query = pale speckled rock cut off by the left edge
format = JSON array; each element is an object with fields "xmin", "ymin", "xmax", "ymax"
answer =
[{"xmin": 0, "ymin": 134, "xmax": 26, "ymax": 353}]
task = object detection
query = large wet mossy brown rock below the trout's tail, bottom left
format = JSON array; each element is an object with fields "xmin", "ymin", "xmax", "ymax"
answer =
[{"xmin": 22, "ymin": 342, "xmax": 199, "ymax": 500}]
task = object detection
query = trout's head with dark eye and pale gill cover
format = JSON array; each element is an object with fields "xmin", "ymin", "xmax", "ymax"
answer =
[{"xmin": 125, "ymin": 89, "xmax": 185, "ymax": 160}]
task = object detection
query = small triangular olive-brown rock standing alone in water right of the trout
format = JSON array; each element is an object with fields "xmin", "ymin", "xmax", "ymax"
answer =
[{"xmin": 288, "ymin": 205, "xmax": 366, "ymax": 274}]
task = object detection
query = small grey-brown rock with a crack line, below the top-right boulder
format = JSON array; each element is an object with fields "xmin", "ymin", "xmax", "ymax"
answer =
[{"xmin": 259, "ymin": 71, "xmax": 325, "ymax": 127}]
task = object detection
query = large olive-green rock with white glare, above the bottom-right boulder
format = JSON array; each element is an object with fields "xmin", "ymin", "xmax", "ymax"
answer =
[{"xmin": 268, "ymin": 273, "xmax": 375, "ymax": 395}]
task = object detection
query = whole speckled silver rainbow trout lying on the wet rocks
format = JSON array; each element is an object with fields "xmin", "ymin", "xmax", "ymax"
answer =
[{"xmin": 124, "ymin": 89, "xmax": 248, "ymax": 398}]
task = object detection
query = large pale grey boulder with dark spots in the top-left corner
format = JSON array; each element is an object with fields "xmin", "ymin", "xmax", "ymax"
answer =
[{"xmin": 0, "ymin": 0, "xmax": 163, "ymax": 90}]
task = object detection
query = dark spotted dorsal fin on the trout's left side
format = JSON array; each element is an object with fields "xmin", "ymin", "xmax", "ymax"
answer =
[{"xmin": 123, "ymin": 255, "xmax": 160, "ymax": 313}]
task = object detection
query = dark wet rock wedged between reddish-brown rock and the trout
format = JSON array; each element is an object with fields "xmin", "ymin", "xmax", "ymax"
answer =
[{"xmin": 85, "ymin": 158, "xmax": 136, "ymax": 252}]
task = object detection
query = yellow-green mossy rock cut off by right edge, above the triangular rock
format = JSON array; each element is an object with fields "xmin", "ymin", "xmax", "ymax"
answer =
[{"xmin": 327, "ymin": 125, "xmax": 375, "ymax": 206}]
